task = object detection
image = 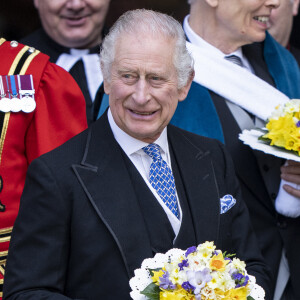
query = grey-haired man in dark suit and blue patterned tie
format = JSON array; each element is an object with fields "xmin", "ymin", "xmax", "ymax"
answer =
[{"xmin": 4, "ymin": 10, "xmax": 270, "ymax": 300}]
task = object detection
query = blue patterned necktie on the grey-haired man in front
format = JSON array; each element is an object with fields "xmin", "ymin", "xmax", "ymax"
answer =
[{"xmin": 143, "ymin": 144, "xmax": 179, "ymax": 219}]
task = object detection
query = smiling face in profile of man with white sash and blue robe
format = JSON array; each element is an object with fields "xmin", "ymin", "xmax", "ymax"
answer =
[{"xmin": 213, "ymin": 0, "xmax": 279, "ymax": 47}]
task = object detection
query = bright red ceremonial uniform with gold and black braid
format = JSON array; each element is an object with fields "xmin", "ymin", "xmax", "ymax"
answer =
[{"xmin": 0, "ymin": 39, "xmax": 87, "ymax": 299}]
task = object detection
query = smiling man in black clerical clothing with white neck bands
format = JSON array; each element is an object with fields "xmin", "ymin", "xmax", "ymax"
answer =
[{"xmin": 21, "ymin": 0, "xmax": 110, "ymax": 124}]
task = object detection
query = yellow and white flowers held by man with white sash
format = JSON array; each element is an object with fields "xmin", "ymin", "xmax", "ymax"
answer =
[{"xmin": 259, "ymin": 99, "xmax": 300, "ymax": 155}]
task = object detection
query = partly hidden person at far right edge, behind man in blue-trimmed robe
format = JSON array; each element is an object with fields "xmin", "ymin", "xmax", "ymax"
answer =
[{"xmin": 268, "ymin": 0, "xmax": 300, "ymax": 65}]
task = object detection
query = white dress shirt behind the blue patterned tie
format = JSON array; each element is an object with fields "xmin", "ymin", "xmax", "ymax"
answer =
[{"xmin": 108, "ymin": 109, "xmax": 182, "ymax": 238}]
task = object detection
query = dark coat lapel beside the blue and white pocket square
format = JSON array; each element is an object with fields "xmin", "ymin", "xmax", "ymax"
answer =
[{"xmin": 168, "ymin": 126, "xmax": 220, "ymax": 244}]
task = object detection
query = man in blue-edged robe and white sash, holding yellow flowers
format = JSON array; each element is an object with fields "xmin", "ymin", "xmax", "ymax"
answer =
[{"xmin": 171, "ymin": 0, "xmax": 300, "ymax": 299}]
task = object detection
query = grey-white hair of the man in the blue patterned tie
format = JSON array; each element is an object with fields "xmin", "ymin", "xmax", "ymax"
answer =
[{"xmin": 100, "ymin": 9, "xmax": 194, "ymax": 89}]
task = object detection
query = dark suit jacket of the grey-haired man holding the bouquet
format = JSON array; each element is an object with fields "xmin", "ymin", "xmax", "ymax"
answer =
[{"xmin": 4, "ymin": 115, "xmax": 269, "ymax": 300}]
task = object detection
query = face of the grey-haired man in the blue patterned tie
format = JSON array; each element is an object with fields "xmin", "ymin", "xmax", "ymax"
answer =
[{"xmin": 104, "ymin": 34, "xmax": 191, "ymax": 143}]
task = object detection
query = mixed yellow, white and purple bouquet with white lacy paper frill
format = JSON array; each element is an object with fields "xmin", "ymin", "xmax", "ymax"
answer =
[{"xmin": 129, "ymin": 242, "xmax": 265, "ymax": 300}]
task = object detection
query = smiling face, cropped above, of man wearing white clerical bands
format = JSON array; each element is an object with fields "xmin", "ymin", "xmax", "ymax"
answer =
[{"xmin": 34, "ymin": 0, "xmax": 110, "ymax": 48}]
